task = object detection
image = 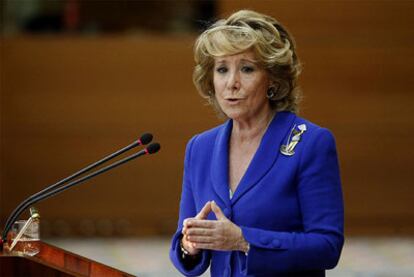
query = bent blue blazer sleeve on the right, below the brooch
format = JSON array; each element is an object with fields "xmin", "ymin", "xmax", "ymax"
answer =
[{"xmin": 237, "ymin": 128, "xmax": 344, "ymax": 275}]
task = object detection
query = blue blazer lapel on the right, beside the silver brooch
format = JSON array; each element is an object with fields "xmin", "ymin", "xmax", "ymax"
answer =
[{"xmin": 231, "ymin": 112, "xmax": 296, "ymax": 205}]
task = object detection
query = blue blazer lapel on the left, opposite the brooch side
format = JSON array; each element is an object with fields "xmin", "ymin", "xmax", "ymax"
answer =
[{"xmin": 210, "ymin": 120, "xmax": 233, "ymax": 207}]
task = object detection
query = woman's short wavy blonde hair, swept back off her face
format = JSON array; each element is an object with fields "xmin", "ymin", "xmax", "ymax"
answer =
[{"xmin": 193, "ymin": 10, "xmax": 301, "ymax": 115}]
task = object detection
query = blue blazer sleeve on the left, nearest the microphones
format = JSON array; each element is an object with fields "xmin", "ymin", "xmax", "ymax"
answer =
[{"xmin": 170, "ymin": 136, "xmax": 211, "ymax": 276}]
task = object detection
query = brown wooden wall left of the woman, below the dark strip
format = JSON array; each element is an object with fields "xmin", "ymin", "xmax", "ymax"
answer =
[{"xmin": 1, "ymin": 37, "xmax": 215, "ymax": 236}]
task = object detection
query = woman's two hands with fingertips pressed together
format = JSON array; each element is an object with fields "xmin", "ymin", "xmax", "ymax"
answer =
[{"xmin": 182, "ymin": 201, "xmax": 249, "ymax": 255}]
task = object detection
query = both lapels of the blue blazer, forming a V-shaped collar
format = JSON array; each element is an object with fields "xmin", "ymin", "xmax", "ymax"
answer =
[{"xmin": 211, "ymin": 112, "xmax": 296, "ymax": 206}]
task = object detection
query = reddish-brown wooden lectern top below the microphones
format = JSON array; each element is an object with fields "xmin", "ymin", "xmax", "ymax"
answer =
[{"xmin": 0, "ymin": 239, "xmax": 133, "ymax": 277}]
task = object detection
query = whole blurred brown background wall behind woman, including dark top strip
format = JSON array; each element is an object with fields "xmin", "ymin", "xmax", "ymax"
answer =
[{"xmin": 0, "ymin": 0, "xmax": 414, "ymax": 237}]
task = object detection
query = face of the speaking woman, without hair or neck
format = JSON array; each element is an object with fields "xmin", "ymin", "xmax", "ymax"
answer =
[{"xmin": 213, "ymin": 50, "xmax": 271, "ymax": 121}]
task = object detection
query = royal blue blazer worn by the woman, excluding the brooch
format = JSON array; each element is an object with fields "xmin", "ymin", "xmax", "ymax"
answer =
[{"xmin": 170, "ymin": 112, "xmax": 344, "ymax": 277}]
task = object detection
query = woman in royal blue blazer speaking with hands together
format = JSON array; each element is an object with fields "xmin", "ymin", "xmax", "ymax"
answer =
[{"xmin": 170, "ymin": 11, "xmax": 344, "ymax": 277}]
